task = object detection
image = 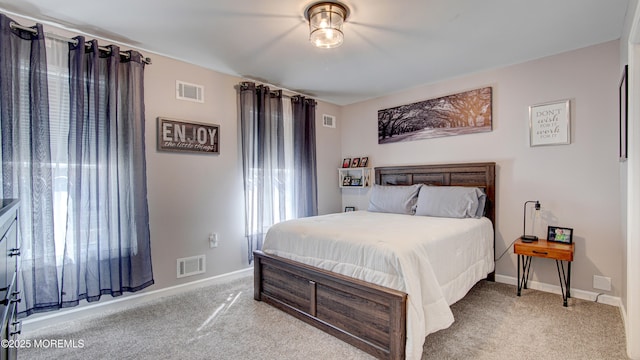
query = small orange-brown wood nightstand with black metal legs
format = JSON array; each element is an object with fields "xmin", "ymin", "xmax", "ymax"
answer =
[{"xmin": 513, "ymin": 239, "xmax": 575, "ymax": 306}]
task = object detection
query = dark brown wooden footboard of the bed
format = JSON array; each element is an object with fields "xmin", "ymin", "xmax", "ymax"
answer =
[{"xmin": 254, "ymin": 251, "xmax": 407, "ymax": 359}]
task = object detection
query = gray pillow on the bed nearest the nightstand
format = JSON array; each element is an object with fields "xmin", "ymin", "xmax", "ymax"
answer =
[{"xmin": 416, "ymin": 186, "xmax": 487, "ymax": 218}]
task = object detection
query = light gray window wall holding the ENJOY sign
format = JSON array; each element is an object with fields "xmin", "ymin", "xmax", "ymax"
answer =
[{"xmin": 145, "ymin": 54, "xmax": 341, "ymax": 290}]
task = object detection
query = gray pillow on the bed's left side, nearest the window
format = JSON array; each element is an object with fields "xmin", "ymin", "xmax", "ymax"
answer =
[{"xmin": 368, "ymin": 184, "xmax": 422, "ymax": 215}]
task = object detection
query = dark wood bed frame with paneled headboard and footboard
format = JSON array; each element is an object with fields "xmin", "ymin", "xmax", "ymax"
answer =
[{"xmin": 254, "ymin": 163, "xmax": 495, "ymax": 359}]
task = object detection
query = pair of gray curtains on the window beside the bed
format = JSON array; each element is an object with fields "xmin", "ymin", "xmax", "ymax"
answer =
[{"xmin": 239, "ymin": 82, "xmax": 318, "ymax": 263}]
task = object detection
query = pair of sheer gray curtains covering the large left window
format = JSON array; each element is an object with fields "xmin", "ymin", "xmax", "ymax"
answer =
[{"xmin": 0, "ymin": 14, "xmax": 153, "ymax": 315}]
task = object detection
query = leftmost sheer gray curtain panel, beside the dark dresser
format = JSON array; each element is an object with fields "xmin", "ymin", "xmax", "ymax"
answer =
[{"xmin": 0, "ymin": 14, "xmax": 59, "ymax": 311}]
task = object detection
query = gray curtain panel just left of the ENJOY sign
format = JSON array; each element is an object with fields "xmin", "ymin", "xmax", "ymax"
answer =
[{"xmin": 61, "ymin": 37, "xmax": 153, "ymax": 307}]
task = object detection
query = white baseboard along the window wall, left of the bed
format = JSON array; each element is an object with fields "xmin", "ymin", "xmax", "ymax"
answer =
[{"xmin": 22, "ymin": 267, "xmax": 253, "ymax": 334}]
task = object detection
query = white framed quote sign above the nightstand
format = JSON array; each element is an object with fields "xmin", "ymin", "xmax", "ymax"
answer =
[{"xmin": 529, "ymin": 100, "xmax": 571, "ymax": 146}]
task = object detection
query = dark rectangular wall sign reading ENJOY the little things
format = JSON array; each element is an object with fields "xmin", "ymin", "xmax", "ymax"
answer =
[{"xmin": 157, "ymin": 117, "xmax": 220, "ymax": 154}]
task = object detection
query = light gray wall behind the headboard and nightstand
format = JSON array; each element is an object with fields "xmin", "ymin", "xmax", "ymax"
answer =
[{"xmin": 342, "ymin": 41, "xmax": 624, "ymax": 296}]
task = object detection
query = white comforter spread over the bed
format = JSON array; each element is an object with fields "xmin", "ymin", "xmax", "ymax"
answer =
[{"xmin": 263, "ymin": 211, "xmax": 494, "ymax": 359}]
